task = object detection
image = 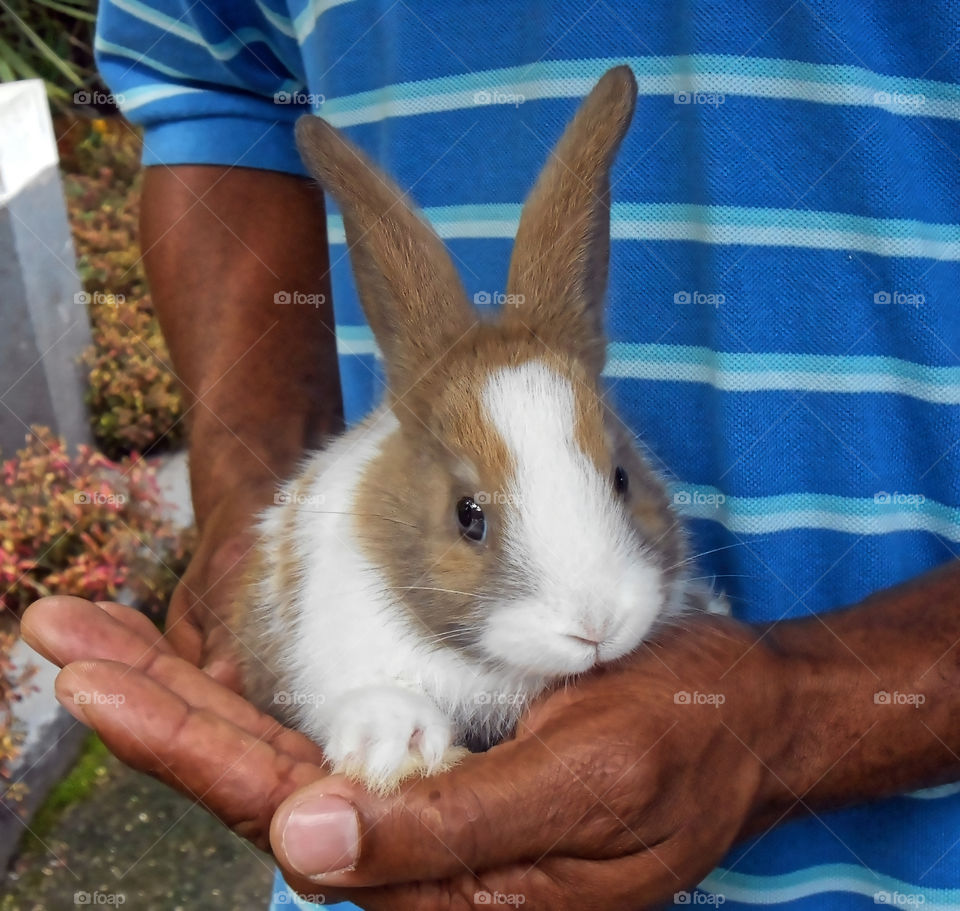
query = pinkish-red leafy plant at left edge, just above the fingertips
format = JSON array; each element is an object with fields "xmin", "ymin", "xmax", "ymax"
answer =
[{"xmin": 0, "ymin": 427, "xmax": 186, "ymax": 614}]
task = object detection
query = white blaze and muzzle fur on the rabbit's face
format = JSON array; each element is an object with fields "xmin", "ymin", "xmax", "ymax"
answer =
[{"xmin": 483, "ymin": 361, "xmax": 666, "ymax": 676}]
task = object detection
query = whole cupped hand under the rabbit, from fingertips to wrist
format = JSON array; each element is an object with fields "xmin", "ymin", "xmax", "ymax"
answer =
[{"xmin": 24, "ymin": 598, "xmax": 785, "ymax": 911}]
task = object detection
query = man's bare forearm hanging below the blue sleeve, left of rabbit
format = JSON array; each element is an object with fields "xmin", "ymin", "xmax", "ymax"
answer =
[{"xmin": 141, "ymin": 160, "xmax": 341, "ymax": 523}]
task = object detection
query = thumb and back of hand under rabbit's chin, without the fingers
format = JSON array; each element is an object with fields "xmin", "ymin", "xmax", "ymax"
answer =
[{"xmin": 271, "ymin": 616, "xmax": 793, "ymax": 911}]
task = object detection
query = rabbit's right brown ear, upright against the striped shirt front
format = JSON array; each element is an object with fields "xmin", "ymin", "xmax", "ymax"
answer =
[{"xmin": 504, "ymin": 66, "xmax": 637, "ymax": 373}]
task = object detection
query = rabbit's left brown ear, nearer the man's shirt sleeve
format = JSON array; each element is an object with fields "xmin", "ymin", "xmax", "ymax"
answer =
[{"xmin": 297, "ymin": 114, "xmax": 476, "ymax": 395}]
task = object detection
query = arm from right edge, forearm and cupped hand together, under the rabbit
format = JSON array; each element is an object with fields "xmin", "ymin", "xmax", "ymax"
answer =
[{"xmin": 23, "ymin": 562, "xmax": 960, "ymax": 911}]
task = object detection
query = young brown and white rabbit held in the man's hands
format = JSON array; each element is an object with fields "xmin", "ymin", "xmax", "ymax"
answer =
[{"xmin": 233, "ymin": 66, "xmax": 706, "ymax": 794}]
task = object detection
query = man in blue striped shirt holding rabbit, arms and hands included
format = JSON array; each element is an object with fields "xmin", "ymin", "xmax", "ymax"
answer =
[{"xmin": 24, "ymin": 0, "xmax": 960, "ymax": 911}]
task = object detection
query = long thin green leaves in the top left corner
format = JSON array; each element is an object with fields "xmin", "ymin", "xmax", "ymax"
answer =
[{"xmin": 0, "ymin": 0, "xmax": 99, "ymax": 107}]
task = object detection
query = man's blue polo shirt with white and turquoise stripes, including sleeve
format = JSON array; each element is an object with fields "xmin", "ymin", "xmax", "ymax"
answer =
[{"xmin": 97, "ymin": 0, "xmax": 960, "ymax": 911}]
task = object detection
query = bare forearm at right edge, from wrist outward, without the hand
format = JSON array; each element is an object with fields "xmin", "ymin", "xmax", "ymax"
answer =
[{"xmin": 750, "ymin": 561, "xmax": 960, "ymax": 830}]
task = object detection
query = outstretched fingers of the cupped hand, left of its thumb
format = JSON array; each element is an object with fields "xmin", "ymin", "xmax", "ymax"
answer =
[{"xmin": 21, "ymin": 597, "xmax": 325, "ymax": 849}]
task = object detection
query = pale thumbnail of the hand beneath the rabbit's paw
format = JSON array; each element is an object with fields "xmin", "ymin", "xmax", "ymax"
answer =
[{"xmin": 281, "ymin": 794, "xmax": 360, "ymax": 879}]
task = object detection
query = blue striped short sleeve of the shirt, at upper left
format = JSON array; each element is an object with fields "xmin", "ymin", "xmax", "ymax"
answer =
[{"xmin": 95, "ymin": 0, "xmax": 316, "ymax": 175}]
